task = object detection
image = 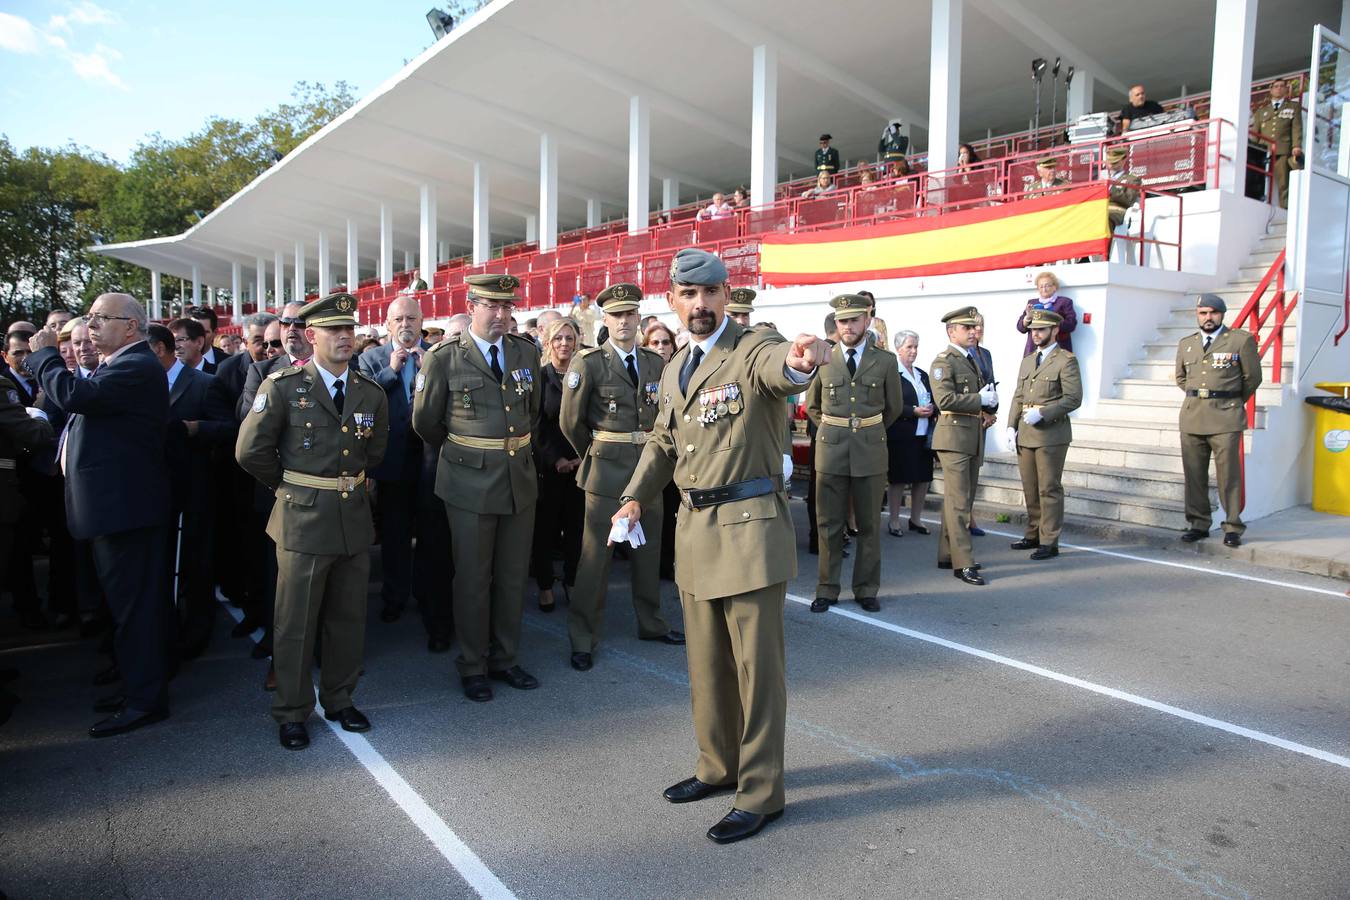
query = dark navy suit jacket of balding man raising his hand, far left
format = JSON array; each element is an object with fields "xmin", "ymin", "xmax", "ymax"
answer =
[{"xmin": 28, "ymin": 340, "xmax": 169, "ymax": 540}]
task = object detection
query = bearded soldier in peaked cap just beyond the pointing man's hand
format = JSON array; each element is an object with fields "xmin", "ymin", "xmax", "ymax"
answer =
[{"xmin": 806, "ymin": 294, "xmax": 903, "ymax": 613}]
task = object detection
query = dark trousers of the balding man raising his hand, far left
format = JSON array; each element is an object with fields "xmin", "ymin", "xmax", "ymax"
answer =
[{"xmin": 89, "ymin": 528, "xmax": 169, "ymax": 710}]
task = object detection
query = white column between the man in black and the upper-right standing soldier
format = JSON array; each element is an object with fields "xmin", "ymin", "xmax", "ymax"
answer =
[{"xmin": 1210, "ymin": 0, "xmax": 1257, "ymax": 194}]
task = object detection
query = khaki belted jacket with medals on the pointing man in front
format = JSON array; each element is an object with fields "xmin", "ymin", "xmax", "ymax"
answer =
[{"xmin": 616, "ymin": 320, "xmax": 809, "ymax": 600}]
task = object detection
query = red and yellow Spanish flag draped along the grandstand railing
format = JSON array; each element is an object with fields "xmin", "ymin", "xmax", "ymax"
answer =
[{"xmin": 760, "ymin": 184, "xmax": 1110, "ymax": 286}]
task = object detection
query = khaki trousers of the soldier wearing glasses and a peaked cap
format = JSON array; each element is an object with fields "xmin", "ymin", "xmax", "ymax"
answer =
[{"xmin": 446, "ymin": 503, "xmax": 535, "ymax": 676}]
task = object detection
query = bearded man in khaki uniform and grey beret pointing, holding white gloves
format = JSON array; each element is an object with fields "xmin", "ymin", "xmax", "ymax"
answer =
[{"xmin": 614, "ymin": 250, "xmax": 829, "ymax": 843}]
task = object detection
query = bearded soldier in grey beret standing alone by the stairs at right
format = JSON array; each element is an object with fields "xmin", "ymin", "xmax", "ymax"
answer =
[{"xmin": 1176, "ymin": 294, "xmax": 1261, "ymax": 546}]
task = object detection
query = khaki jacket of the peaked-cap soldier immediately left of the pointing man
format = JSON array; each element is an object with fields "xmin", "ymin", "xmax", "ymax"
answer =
[{"xmin": 559, "ymin": 341, "xmax": 666, "ymax": 498}]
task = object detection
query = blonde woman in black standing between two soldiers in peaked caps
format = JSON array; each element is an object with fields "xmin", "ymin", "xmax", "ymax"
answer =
[{"xmin": 531, "ymin": 317, "xmax": 586, "ymax": 613}]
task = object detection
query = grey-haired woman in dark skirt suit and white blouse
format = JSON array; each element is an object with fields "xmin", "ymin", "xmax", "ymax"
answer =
[{"xmin": 886, "ymin": 331, "xmax": 937, "ymax": 537}]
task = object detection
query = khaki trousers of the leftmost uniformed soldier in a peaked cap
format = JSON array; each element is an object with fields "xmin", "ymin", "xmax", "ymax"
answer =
[{"xmin": 271, "ymin": 546, "xmax": 370, "ymax": 723}]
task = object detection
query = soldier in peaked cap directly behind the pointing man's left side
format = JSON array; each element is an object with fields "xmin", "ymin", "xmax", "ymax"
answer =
[{"xmin": 559, "ymin": 285, "xmax": 684, "ymax": 672}]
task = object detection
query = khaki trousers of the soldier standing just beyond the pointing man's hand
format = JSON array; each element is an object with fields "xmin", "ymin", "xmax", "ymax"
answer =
[{"xmin": 815, "ymin": 472, "xmax": 886, "ymax": 600}]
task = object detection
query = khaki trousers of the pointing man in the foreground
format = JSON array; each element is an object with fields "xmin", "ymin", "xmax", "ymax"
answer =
[{"xmin": 680, "ymin": 582, "xmax": 787, "ymax": 814}]
